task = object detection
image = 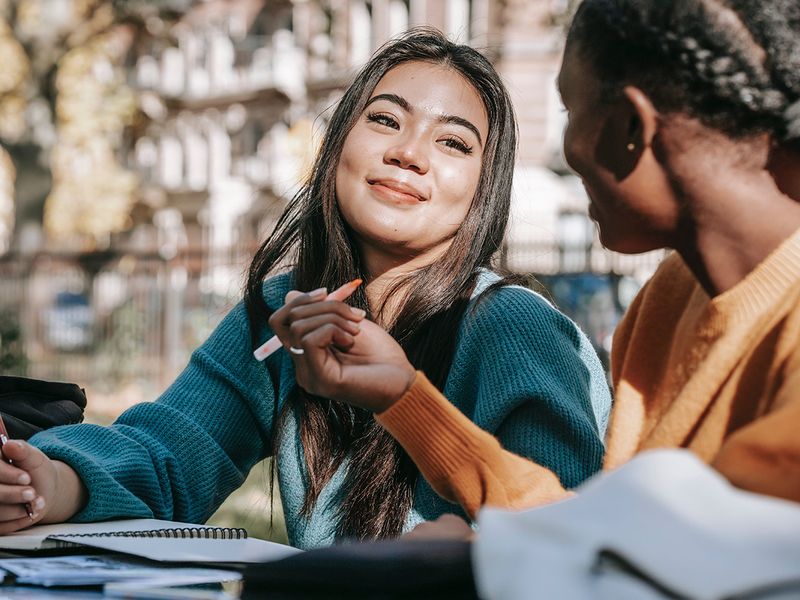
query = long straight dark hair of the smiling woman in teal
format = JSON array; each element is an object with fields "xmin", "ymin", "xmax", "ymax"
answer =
[{"xmin": 245, "ymin": 28, "xmax": 517, "ymax": 540}]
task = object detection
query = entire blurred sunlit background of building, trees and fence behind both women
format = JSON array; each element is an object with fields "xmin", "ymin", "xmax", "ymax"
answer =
[{"xmin": 0, "ymin": 0, "xmax": 662, "ymax": 539}]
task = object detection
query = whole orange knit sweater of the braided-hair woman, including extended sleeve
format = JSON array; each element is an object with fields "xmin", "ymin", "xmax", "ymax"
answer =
[{"xmin": 376, "ymin": 231, "xmax": 800, "ymax": 516}]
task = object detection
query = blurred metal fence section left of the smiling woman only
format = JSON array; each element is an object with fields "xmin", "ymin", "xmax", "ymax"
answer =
[{"xmin": 0, "ymin": 252, "xmax": 246, "ymax": 404}]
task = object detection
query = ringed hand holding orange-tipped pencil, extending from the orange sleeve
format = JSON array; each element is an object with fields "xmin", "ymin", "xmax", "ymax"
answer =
[{"xmin": 269, "ymin": 280, "xmax": 416, "ymax": 412}]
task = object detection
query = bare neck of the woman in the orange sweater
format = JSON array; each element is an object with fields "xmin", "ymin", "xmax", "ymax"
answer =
[{"xmin": 676, "ymin": 171, "xmax": 800, "ymax": 297}]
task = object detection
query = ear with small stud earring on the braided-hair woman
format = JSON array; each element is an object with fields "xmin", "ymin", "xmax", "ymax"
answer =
[{"xmin": 595, "ymin": 85, "xmax": 659, "ymax": 181}]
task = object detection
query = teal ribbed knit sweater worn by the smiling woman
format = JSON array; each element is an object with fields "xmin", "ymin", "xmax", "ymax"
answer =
[{"xmin": 30, "ymin": 273, "xmax": 611, "ymax": 548}]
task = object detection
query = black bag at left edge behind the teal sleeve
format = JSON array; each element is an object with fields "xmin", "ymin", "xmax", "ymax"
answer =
[{"xmin": 0, "ymin": 375, "xmax": 86, "ymax": 440}]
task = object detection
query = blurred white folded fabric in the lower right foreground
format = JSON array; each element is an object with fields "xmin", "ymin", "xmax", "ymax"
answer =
[{"xmin": 473, "ymin": 450, "xmax": 800, "ymax": 600}]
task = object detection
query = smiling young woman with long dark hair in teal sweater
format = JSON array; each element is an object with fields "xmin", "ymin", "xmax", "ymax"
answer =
[{"xmin": 0, "ymin": 29, "xmax": 610, "ymax": 547}]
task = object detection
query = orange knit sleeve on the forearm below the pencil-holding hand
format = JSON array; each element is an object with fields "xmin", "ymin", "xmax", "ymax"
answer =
[{"xmin": 375, "ymin": 373, "xmax": 571, "ymax": 518}]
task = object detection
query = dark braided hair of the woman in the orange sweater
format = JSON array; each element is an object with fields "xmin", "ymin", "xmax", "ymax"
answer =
[{"xmin": 567, "ymin": 0, "xmax": 800, "ymax": 148}]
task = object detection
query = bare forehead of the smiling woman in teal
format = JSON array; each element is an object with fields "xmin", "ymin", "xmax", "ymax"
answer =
[{"xmin": 372, "ymin": 61, "xmax": 488, "ymax": 140}]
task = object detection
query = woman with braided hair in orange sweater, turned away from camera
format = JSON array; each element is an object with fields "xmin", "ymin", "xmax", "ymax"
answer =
[{"xmin": 272, "ymin": 0, "xmax": 800, "ymax": 515}]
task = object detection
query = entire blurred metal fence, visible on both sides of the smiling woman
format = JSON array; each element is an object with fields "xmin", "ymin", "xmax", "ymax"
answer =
[{"xmin": 0, "ymin": 239, "xmax": 662, "ymax": 399}]
